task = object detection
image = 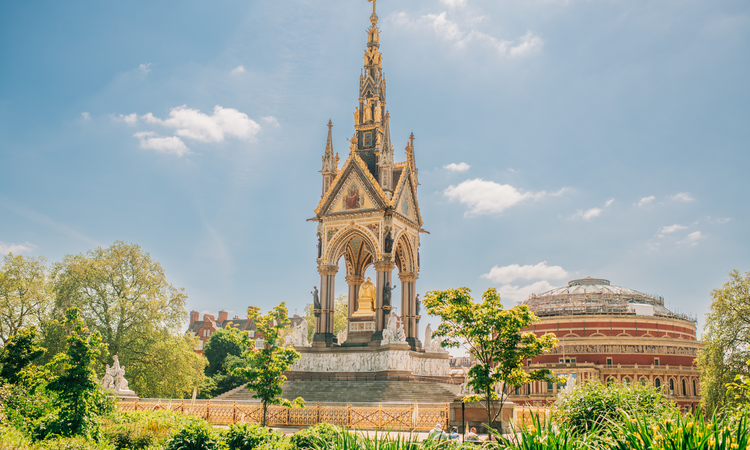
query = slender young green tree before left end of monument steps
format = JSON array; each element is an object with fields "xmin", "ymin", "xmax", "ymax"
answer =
[{"xmin": 232, "ymin": 302, "xmax": 305, "ymax": 426}]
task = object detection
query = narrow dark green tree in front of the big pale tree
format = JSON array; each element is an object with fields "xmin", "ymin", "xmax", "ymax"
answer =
[{"xmin": 46, "ymin": 308, "xmax": 111, "ymax": 436}]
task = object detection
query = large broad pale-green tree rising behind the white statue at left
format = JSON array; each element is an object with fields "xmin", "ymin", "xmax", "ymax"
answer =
[{"xmin": 51, "ymin": 241, "xmax": 195, "ymax": 397}]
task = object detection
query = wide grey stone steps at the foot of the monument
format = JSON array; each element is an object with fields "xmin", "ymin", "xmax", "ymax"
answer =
[{"xmin": 215, "ymin": 381, "xmax": 460, "ymax": 403}]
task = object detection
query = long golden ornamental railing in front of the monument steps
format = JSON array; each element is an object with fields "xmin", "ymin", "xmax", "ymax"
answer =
[{"xmin": 119, "ymin": 398, "xmax": 450, "ymax": 431}]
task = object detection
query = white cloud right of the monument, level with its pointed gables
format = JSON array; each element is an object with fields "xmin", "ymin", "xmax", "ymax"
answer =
[{"xmin": 443, "ymin": 178, "xmax": 546, "ymax": 215}]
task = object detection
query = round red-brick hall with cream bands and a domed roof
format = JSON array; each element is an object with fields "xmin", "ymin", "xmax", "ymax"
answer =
[{"xmin": 510, "ymin": 277, "xmax": 703, "ymax": 410}]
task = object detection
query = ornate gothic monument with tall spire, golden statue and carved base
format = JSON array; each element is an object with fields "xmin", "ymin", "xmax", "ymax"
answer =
[{"xmin": 287, "ymin": 2, "xmax": 453, "ymax": 383}]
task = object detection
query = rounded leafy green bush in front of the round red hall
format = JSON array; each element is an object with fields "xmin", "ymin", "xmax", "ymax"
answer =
[{"xmin": 553, "ymin": 381, "xmax": 679, "ymax": 432}]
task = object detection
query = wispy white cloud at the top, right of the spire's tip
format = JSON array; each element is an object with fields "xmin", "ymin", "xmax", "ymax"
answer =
[{"xmin": 389, "ymin": 11, "xmax": 544, "ymax": 58}]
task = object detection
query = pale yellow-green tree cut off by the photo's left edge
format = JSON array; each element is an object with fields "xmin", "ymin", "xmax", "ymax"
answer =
[{"xmin": 0, "ymin": 254, "xmax": 54, "ymax": 343}]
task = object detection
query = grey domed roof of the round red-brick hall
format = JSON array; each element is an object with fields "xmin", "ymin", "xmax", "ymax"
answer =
[{"xmin": 524, "ymin": 277, "xmax": 694, "ymax": 321}]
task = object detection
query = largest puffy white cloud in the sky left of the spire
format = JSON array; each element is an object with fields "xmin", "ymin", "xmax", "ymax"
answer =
[{"xmin": 141, "ymin": 105, "xmax": 261, "ymax": 142}]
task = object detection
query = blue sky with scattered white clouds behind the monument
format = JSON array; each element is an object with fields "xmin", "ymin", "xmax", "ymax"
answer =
[{"xmin": 0, "ymin": 0, "xmax": 750, "ymax": 338}]
